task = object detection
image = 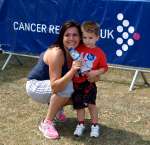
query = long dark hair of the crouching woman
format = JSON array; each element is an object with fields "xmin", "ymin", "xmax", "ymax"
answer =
[{"xmin": 51, "ymin": 21, "xmax": 82, "ymax": 52}]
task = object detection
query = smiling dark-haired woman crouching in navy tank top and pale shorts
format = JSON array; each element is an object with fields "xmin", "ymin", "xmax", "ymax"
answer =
[{"xmin": 26, "ymin": 21, "xmax": 82, "ymax": 139}]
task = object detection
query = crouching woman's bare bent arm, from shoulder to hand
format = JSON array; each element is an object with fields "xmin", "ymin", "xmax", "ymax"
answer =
[{"xmin": 46, "ymin": 48, "xmax": 80, "ymax": 93}]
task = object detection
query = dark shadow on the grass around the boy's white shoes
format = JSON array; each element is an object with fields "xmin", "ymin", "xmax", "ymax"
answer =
[{"xmin": 57, "ymin": 118, "xmax": 150, "ymax": 145}]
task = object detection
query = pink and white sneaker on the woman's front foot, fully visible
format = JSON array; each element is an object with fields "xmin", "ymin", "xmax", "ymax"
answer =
[{"xmin": 39, "ymin": 120, "xmax": 59, "ymax": 139}]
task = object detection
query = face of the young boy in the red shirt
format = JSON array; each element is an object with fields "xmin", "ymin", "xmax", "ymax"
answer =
[{"xmin": 82, "ymin": 31, "xmax": 99, "ymax": 48}]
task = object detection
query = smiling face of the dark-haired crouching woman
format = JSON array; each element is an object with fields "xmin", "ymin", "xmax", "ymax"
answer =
[{"xmin": 63, "ymin": 27, "xmax": 81, "ymax": 48}]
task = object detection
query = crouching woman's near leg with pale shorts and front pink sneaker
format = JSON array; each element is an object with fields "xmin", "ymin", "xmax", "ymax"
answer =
[{"xmin": 26, "ymin": 80, "xmax": 73, "ymax": 139}]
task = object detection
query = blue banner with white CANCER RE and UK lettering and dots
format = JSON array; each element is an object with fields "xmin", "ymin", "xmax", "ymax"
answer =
[{"xmin": 0, "ymin": 0, "xmax": 150, "ymax": 68}]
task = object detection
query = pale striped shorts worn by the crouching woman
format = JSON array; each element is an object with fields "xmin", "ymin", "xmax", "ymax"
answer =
[{"xmin": 26, "ymin": 79, "xmax": 74, "ymax": 104}]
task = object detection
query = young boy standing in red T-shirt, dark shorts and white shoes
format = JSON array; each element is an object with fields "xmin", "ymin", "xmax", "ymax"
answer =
[{"xmin": 72, "ymin": 21, "xmax": 108, "ymax": 138}]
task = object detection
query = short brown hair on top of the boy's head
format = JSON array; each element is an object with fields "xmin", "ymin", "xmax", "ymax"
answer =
[{"xmin": 81, "ymin": 21, "xmax": 100, "ymax": 36}]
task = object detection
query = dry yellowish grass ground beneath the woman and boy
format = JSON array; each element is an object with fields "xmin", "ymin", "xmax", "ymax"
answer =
[{"xmin": 0, "ymin": 55, "xmax": 150, "ymax": 145}]
